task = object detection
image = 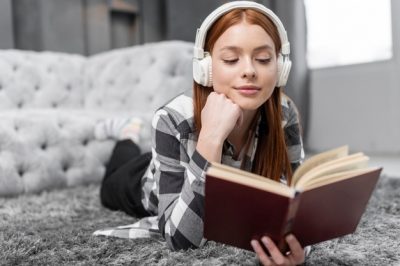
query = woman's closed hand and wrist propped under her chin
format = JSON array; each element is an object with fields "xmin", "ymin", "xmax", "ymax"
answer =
[{"xmin": 196, "ymin": 92, "xmax": 243, "ymax": 162}]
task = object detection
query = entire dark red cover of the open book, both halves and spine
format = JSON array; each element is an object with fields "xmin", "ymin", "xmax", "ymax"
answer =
[{"xmin": 204, "ymin": 169, "xmax": 382, "ymax": 251}]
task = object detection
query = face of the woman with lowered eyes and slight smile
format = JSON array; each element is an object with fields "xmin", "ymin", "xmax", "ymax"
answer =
[{"xmin": 212, "ymin": 21, "xmax": 277, "ymax": 110}]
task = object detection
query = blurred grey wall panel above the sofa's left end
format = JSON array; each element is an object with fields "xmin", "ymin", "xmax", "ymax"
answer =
[{"xmin": 13, "ymin": 0, "xmax": 85, "ymax": 54}]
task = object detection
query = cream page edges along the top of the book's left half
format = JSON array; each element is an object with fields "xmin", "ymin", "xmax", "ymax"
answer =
[{"xmin": 206, "ymin": 163, "xmax": 295, "ymax": 198}]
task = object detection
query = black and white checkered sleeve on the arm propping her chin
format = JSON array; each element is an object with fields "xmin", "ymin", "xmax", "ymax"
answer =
[{"xmin": 153, "ymin": 109, "xmax": 208, "ymax": 250}]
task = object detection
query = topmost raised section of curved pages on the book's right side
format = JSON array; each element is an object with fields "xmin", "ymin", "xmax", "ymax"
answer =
[{"xmin": 292, "ymin": 145, "xmax": 349, "ymax": 186}]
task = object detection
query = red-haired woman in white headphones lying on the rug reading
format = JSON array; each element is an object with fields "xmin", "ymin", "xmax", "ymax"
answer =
[{"xmin": 101, "ymin": 1, "xmax": 304, "ymax": 265}]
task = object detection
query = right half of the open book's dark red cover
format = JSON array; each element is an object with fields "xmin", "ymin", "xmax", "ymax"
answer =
[{"xmin": 292, "ymin": 169, "xmax": 382, "ymax": 246}]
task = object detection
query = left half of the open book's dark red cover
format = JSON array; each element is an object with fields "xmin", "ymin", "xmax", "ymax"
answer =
[{"xmin": 204, "ymin": 172, "xmax": 291, "ymax": 250}]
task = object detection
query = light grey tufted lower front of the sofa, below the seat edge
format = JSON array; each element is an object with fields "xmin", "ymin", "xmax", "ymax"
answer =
[{"xmin": 0, "ymin": 109, "xmax": 115, "ymax": 196}]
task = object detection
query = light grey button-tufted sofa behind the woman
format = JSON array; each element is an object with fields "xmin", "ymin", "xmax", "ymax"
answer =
[{"xmin": 0, "ymin": 41, "xmax": 193, "ymax": 196}]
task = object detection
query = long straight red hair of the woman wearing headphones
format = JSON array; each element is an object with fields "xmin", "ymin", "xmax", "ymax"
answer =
[{"xmin": 193, "ymin": 9, "xmax": 292, "ymax": 183}]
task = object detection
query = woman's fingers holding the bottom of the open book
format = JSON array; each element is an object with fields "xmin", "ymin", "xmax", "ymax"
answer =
[{"xmin": 251, "ymin": 234, "xmax": 305, "ymax": 265}]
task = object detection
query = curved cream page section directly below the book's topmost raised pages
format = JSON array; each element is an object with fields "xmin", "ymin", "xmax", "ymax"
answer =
[{"xmin": 296, "ymin": 153, "xmax": 369, "ymax": 188}]
